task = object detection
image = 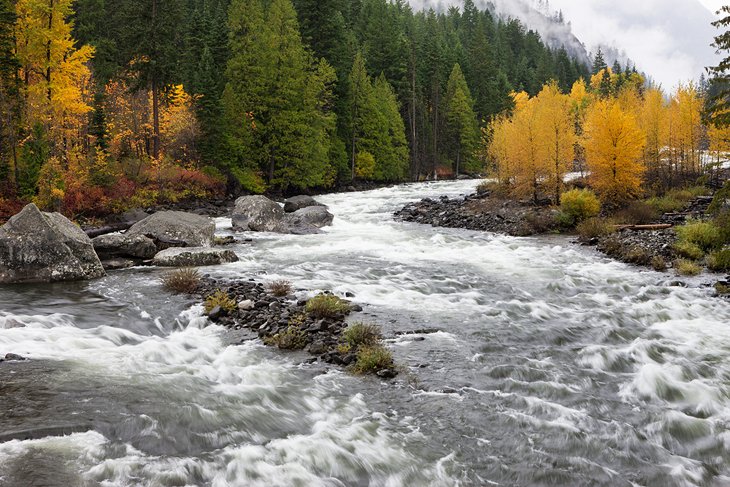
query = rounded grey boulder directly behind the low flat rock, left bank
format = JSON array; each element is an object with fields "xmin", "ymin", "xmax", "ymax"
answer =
[{"xmin": 126, "ymin": 211, "xmax": 215, "ymax": 249}]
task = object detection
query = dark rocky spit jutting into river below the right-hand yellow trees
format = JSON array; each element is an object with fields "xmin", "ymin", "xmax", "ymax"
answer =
[{"xmin": 395, "ymin": 192, "xmax": 559, "ymax": 236}]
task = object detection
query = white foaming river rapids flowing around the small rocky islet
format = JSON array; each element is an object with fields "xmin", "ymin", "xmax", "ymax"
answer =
[{"xmin": 0, "ymin": 181, "xmax": 730, "ymax": 487}]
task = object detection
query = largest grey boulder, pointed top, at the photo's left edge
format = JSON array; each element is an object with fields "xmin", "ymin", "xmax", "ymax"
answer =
[{"xmin": 0, "ymin": 203, "xmax": 105, "ymax": 283}]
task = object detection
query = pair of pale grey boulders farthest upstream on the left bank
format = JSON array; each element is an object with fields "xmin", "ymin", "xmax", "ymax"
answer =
[{"xmin": 231, "ymin": 196, "xmax": 334, "ymax": 235}]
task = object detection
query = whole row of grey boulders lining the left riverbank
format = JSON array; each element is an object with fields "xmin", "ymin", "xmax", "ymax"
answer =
[{"xmin": 0, "ymin": 196, "xmax": 334, "ymax": 283}]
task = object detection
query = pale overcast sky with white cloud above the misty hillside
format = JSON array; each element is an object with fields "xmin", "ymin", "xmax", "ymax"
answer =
[{"xmin": 550, "ymin": 0, "xmax": 724, "ymax": 89}]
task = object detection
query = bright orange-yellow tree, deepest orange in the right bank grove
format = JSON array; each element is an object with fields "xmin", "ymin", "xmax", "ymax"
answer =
[{"xmin": 585, "ymin": 100, "xmax": 646, "ymax": 202}]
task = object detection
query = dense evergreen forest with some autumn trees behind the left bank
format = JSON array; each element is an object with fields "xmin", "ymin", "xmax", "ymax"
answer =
[{"xmin": 0, "ymin": 0, "xmax": 590, "ymax": 219}]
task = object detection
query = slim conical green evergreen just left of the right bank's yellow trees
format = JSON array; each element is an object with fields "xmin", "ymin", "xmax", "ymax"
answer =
[{"xmin": 445, "ymin": 64, "xmax": 479, "ymax": 176}]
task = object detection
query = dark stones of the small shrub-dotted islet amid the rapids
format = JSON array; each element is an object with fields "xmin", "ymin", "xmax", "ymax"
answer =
[{"xmin": 196, "ymin": 277, "xmax": 397, "ymax": 378}]
